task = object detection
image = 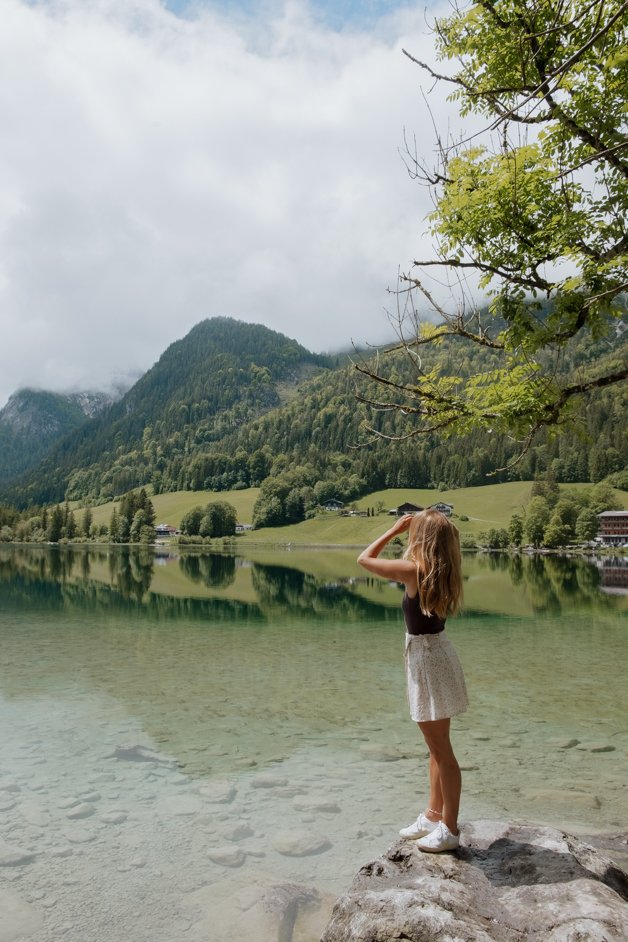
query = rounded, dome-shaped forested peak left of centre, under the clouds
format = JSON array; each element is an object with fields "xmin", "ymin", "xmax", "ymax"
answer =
[{"xmin": 2, "ymin": 317, "xmax": 335, "ymax": 506}]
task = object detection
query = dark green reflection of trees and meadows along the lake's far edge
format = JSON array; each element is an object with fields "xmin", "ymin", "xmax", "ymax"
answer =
[{"xmin": 0, "ymin": 547, "xmax": 628, "ymax": 621}]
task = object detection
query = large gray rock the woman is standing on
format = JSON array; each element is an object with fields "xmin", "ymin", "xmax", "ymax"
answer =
[{"xmin": 321, "ymin": 821, "xmax": 628, "ymax": 942}]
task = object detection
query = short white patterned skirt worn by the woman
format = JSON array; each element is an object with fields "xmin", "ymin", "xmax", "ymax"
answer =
[{"xmin": 405, "ymin": 631, "xmax": 469, "ymax": 723}]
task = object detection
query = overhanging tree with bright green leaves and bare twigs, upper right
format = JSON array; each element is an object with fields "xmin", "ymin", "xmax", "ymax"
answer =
[{"xmin": 357, "ymin": 0, "xmax": 628, "ymax": 464}]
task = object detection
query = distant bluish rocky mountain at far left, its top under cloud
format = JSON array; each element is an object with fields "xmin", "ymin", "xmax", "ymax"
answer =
[{"xmin": 0, "ymin": 389, "xmax": 112, "ymax": 481}]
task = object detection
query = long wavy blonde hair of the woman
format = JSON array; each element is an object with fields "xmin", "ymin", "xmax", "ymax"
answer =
[{"xmin": 403, "ymin": 510, "xmax": 462, "ymax": 619}]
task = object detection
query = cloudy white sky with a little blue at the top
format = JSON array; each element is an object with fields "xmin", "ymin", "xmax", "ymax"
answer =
[{"xmin": 0, "ymin": 0, "xmax": 448, "ymax": 407}]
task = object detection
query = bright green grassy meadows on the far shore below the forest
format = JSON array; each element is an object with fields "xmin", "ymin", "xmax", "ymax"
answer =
[{"xmin": 79, "ymin": 481, "xmax": 628, "ymax": 546}]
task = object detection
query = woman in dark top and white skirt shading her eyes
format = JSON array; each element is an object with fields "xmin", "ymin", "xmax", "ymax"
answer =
[{"xmin": 358, "ymin": 510, "xmax": 469, "ymax": 853}]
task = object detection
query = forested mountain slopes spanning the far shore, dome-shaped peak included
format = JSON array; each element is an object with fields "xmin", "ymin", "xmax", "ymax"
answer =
[{"xmin": 3, "ymin": 318, "xmax": 628, "ymax": 506}]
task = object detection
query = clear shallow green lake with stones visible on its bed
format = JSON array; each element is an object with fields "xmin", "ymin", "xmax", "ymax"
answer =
[{"xmin": 0, "ymin": 547, "xmax": 628, "ymax": 942}]
